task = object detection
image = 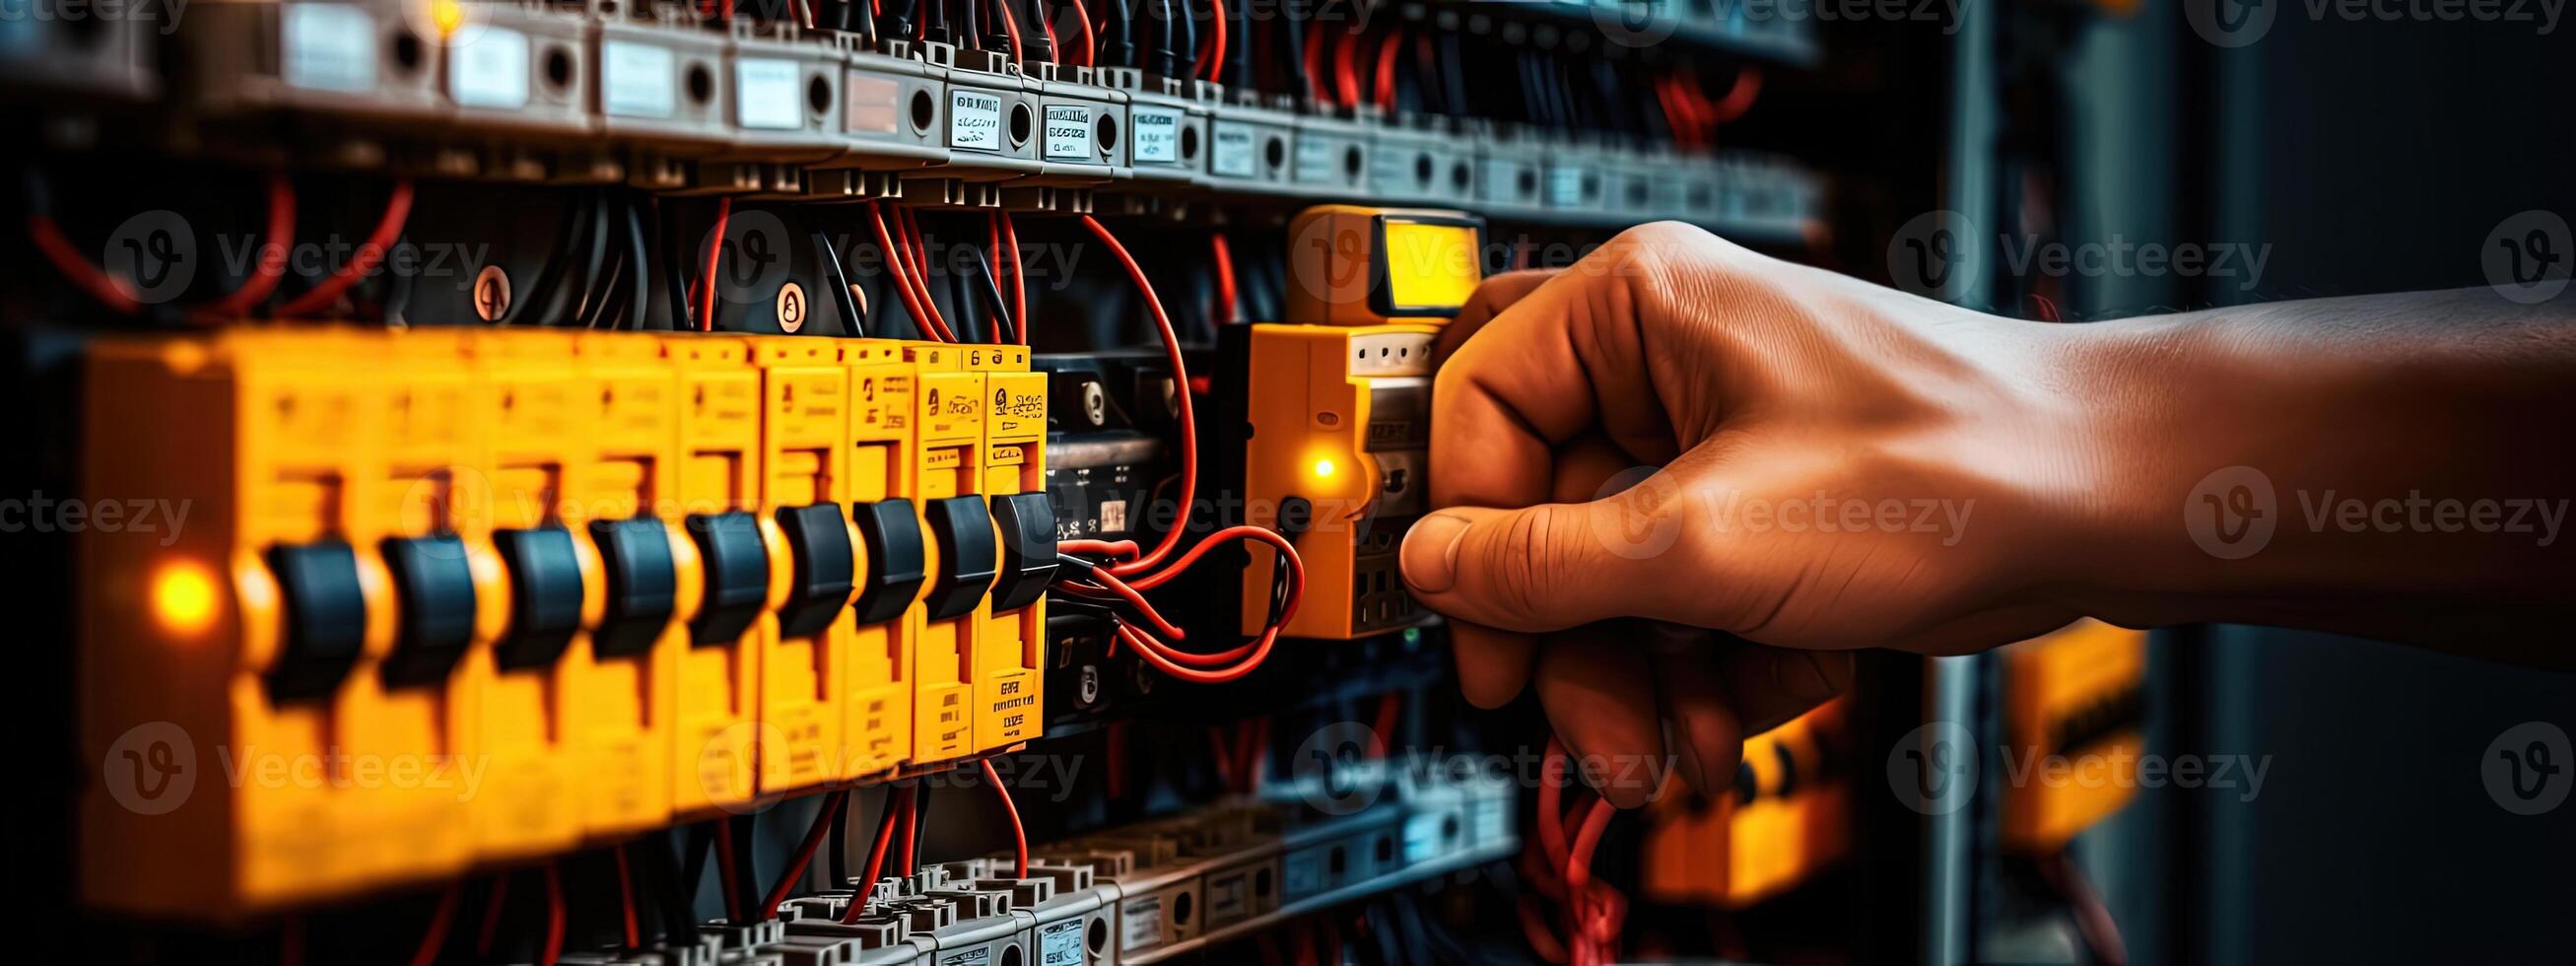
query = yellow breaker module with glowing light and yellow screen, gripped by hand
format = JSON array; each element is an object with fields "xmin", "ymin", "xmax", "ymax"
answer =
[{"xmin": 1218, "ymin": 206, "xmax": 1484, "ymax": 639}]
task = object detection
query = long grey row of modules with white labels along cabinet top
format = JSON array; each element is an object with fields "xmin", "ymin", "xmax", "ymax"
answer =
[{"xmin": 0, "ymin": 0, "xmax": 1818, "ymax": 240}]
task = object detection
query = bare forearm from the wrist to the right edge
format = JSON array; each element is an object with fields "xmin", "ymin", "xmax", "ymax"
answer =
[{"xmin": 2053, "ymin": 291, "xmax": 2576, "ymax": 662}]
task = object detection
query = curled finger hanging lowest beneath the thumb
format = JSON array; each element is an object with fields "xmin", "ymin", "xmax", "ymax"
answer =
[{"xmin": 1538, "ymin": 626, "xmax": 1664, "ymax": 809}]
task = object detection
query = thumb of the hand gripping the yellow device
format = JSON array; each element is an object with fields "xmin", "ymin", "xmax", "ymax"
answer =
[{"xmin": 1398, "ymin": 495, "xmax": 1679, "ymax": 631}]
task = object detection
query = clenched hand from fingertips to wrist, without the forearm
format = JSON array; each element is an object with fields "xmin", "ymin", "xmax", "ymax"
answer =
[{"xmin": 1401, "ymin": 224, "xmax": 2089, "ymax": 806}]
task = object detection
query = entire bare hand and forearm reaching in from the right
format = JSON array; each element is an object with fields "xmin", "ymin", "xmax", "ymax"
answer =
[{"xmin": 1401, "ymin": 224, "xmax": 2576, "ymax": 806}]
